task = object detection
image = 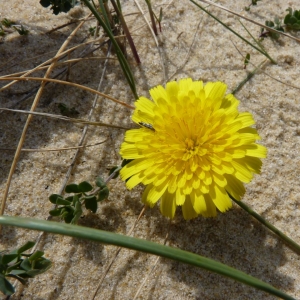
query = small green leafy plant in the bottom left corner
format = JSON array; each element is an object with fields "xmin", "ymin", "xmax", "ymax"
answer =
[{"xmin": 0, "ymin": 241, "xmax": 52, "ymax": 296}]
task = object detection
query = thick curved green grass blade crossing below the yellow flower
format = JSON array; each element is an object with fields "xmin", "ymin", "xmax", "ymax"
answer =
[{"xmin": 0, "ymin": 216, "xmax": 294, "ymax": 300}]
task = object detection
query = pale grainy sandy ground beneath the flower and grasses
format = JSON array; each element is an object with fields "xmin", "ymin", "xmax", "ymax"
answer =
[{"xmin": 0, "ymin": 0, "xmax": 300, "ymax": 300}]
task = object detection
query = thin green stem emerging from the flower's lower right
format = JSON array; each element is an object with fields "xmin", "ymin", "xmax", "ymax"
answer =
[{"xmin": 229, "ymin": 195, "xmax": 300, "ymax": 254}]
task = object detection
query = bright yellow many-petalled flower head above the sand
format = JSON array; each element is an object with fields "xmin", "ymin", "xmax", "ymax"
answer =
[{"xmin": 120, "ymin": 78, "xmax": 267, "ymax": 220}]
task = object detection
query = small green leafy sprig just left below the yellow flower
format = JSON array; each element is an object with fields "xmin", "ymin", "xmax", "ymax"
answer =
[{"xmin": 49, "ymin": 177, "xmax": 109, "ymax": 224}]
